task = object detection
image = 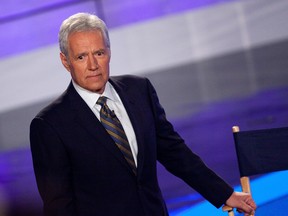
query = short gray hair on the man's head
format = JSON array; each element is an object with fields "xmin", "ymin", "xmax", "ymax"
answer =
[{"xmin": 58, "ymin": 13, "xmax": 110, "ymax": 57}]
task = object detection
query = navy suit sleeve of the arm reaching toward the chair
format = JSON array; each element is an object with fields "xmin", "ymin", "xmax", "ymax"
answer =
[{"xmin": 148, "ymin": 78, "xmax": 233, "ymax": 208}]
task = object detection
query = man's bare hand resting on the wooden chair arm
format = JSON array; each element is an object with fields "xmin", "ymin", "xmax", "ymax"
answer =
[{"xmin": 225, "ymin": 192, "xmax": 257, "ymax": 216}]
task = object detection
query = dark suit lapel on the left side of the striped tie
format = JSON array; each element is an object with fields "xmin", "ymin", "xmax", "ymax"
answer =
[{"xmin": 68, "ymin": 84, "xmax": 133, "ymax": 173}]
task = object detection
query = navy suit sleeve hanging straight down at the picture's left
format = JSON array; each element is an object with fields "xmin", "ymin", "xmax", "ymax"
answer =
[{"xmin": 30, "ymin": 118, "xmax": 75, "ymax": 216}]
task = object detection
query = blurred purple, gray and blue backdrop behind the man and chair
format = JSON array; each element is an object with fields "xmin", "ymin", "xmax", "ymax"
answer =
[{"xmin": 0, "ymin": 0, "xmax": 288, "ymax": 216}]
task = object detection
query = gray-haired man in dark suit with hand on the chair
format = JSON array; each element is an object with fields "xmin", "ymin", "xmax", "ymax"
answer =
[{"xmin": 30, "ymin": 13, "xmax": 256, "ymax": 216}]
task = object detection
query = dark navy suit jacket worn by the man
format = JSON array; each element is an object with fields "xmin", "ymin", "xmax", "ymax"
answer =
[{"xmin": 30, "ymin": 76, "xmax": 233, "ymax": 216}]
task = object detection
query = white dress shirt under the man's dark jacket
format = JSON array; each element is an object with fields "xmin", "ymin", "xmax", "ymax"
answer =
[{"xmin": 72, "ymin": 80, "xmax": 138, "ymax": 167}]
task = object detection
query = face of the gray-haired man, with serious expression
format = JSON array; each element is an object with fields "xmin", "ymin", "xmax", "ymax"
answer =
[{"xmin": 60, "ymin": 30, "xmax": 110, "ymax": 94}]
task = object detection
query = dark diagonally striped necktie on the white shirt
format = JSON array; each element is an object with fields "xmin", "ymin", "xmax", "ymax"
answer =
[{"xmin": 96, "ymin": 96, "xmax": 136, "ymax": 175}]
